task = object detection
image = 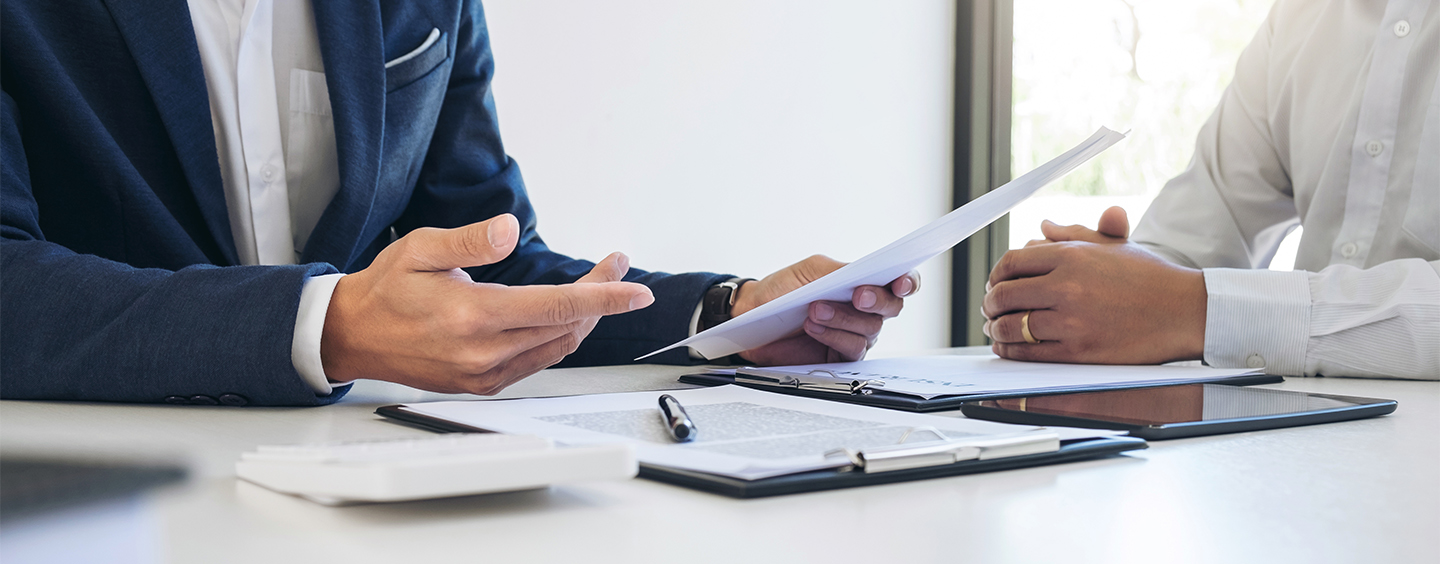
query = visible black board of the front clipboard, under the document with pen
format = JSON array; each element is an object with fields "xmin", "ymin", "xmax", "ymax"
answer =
[{"xmin": 374, "ymin": 406, "xmax": 1146, "ymax": 499}]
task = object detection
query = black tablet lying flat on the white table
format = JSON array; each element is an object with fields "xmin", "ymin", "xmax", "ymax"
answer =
[{"xmin": 960, "ymin": 384, "xmax": 1397, "ymax": 439}]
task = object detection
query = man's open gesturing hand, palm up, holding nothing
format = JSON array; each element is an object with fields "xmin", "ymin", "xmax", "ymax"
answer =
[{"xmin": 320, "ymin": 214, "xmax": 655, "ymax": 394}]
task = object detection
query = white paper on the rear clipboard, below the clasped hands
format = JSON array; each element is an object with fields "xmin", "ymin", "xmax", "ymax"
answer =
[{"xmin": 737, "ymin": 355, "xmax": 1260, "ymax": 399}]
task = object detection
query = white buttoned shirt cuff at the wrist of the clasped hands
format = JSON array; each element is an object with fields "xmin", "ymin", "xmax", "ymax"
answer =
[{"xmin": 1204, "ymin": 268, "xmax": 1310, "ymax": 376}]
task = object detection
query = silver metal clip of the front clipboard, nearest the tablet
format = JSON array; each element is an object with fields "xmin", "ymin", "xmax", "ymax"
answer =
[{"xmin": 825, "ymin": 427, "xmax": 1060, "ymax": 473}]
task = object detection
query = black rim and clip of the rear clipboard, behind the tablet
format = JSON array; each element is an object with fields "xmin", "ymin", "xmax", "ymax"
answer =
[{"xmin": 680, "ymin": 367, "xmax": 1284, "ymax": 413}]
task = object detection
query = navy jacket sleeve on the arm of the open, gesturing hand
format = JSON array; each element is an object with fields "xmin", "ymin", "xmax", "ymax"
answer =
[{"xmin": 0, "ymin": 94, "xmax": 344, "ymax": 406}]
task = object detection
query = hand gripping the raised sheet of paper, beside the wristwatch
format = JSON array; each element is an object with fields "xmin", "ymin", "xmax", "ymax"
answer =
[{"xmin": 732, "ymin": 255, "xmax": 920, "ymax": 365}]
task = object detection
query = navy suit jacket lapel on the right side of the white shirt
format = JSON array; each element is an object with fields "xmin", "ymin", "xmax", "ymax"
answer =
[{"xmin": 301, "ymin": 0, "xmax": 384, "ymax": 270}]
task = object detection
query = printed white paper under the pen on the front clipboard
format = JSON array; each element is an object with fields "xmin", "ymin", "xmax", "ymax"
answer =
[{"xmin": 405, "ymin": 386, "xmax": 1119, "ymax": 479}]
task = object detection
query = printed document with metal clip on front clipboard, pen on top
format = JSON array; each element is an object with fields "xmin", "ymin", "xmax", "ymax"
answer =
[{"xmin": 379, "ymin": 386, "xmax": 1119, "ymax": 481}]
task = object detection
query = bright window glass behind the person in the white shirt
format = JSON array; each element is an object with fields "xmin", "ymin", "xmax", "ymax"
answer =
[{"xmin": 1009, "ymin": 0, "xmax": 1299, "ymax": 270}]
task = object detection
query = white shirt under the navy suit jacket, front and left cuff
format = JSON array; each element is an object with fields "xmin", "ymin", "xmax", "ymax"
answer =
[{"xmin": 189, "ymin": 0, "xmax": 341, "ymax": 394}]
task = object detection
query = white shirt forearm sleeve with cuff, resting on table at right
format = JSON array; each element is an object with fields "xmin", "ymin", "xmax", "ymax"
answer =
[{"xmin": 1204, "ymin": 259, "xmax": 1440, "ymax": 380}]
